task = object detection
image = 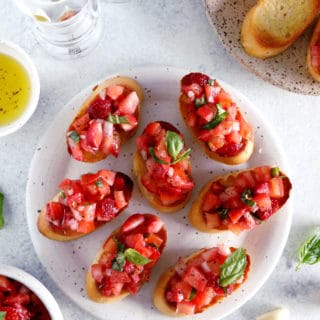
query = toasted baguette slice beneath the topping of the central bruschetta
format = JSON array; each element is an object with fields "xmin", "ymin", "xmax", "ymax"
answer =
[{"xmin": 133, "ymin": 121, "xmax": 194, "ymax": 213}]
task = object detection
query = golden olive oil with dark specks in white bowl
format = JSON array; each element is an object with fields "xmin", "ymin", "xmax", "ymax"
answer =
[{"xmin": 0, "ymin": 53, "xmax": 31, "ymax": 126}]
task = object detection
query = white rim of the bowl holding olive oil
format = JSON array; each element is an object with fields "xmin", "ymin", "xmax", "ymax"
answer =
[{"xmin": 0, "ymin": 40, "xmax": 40, "ymax": 137}]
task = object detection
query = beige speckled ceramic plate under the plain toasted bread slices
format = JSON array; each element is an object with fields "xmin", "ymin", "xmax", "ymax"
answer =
[{"xmin": 204, "ymin": 0, "xmax": 320, "ymax": 95}]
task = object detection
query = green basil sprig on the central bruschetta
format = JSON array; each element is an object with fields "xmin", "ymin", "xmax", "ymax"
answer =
[{"xmin": 149, "ymin": 130, "xmax": 191, "ymax": 164}]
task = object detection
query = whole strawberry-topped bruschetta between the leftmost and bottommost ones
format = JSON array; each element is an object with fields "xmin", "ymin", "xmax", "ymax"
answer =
[{"xmin": 86, "ymin": 213, "xmax": 167, "ymax": 303}]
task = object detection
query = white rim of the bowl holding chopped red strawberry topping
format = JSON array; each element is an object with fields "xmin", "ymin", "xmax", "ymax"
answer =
[{"xmin": 0, "ymin": 264, "xmax": 63, "ymax": 320}]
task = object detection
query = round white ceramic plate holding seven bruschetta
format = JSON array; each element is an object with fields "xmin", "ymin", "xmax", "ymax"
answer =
[{"xmin": 27, "ymin": 67, "xmax": 291, "ymax": 320}]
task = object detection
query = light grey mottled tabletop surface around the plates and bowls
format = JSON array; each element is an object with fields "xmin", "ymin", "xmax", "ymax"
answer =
[{"xmin": 0, "ymin": 0, "xmax": 320, "ymax": 320}]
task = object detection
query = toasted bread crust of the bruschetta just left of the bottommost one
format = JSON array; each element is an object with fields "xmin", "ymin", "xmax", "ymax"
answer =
[{"xmin": 86, "ymin": 214, "xmax": 167, "ymax": 303}]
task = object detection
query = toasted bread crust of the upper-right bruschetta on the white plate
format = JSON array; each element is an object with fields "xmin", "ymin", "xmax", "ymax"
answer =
[{"xmin": 179, "ymin": 95, "xmax": 254, "ymax": 165}]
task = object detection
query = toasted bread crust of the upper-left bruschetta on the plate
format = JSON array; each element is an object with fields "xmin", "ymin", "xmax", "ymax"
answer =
[{"xmin": 67, "ymin": 76, "xmax": 143, "ymax": 162}]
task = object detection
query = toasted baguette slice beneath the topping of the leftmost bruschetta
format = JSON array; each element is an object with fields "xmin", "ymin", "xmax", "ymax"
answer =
[{"xmin": 37, "ymin": 170, "xmax": 133, "ymax": 242}]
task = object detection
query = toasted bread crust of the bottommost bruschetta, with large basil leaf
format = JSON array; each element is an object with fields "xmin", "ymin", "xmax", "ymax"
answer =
[{"xmin": 153, "ymin": 248, "xmax": 250, "ymax": 317}]
